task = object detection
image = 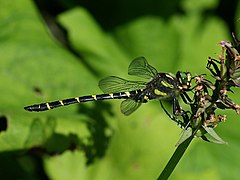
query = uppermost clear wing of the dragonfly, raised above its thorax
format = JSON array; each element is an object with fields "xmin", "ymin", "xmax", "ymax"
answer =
[{"xmin": 128, "ymin": 57, "xmax": 158, "ymax": 79}]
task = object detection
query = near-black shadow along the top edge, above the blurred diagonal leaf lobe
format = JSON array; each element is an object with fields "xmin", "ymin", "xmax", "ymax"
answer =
[{"xmin": 34, "ymin": 0, "xmax": 183, "ymax": 31}]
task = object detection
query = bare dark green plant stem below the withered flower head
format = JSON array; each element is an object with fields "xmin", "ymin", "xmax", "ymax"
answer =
[{"xmin": 158, "ymin": 135, "xmax": 194, "ymax": 180}]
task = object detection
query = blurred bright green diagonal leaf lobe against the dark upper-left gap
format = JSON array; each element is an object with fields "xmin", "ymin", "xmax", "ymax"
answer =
[{"xmin": 58, "ymin": 8, "xmax": 129, "ymax": 74}]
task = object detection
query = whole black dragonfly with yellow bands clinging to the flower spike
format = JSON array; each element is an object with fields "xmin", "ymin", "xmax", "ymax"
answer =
[{"xmin": 24, "ymin": 57, "xmax": 192, "ymax": 116}]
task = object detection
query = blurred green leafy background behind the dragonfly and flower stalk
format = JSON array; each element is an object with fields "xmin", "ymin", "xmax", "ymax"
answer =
[{"xmin": 0, "ymin": 0, "xmax": 240, "ymax": 180}]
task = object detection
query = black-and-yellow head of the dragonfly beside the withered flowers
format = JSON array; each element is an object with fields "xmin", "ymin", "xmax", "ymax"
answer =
[{"xmin": 176, "ymin": 71, "xmax": 192, "ymax": 90}]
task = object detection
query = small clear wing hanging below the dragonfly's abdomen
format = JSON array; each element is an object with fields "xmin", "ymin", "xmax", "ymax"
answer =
[{"xmin": 120, "ymin": 99, "xmax": 142, "ymax": 116}]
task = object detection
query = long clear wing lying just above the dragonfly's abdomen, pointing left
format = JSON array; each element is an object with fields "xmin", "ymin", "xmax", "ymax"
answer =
[{"xmin": 98, "ymin": 76, "xmax": 147, "ymax": 93}]
